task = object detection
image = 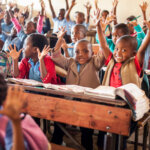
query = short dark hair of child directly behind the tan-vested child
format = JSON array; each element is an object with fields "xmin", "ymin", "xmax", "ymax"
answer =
[{"xmin": 114, "ymin": 23, "xmax": 130, "ymax": 35}]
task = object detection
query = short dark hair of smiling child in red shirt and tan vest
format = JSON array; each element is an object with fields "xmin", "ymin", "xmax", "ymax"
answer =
[{"xmin": 117, "ymin": 35, "xmax": 138, "ymax": 51}]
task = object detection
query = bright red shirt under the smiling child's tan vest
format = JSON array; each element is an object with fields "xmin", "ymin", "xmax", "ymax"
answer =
[{"xmin": 105, "ymin": 53, "xmax": 143, "ymax": 88}]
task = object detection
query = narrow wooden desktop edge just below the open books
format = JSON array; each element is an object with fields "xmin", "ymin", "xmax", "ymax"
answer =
[{"xmin": 8, "ymin": 84, "xmax": 127, "ymax": 106}]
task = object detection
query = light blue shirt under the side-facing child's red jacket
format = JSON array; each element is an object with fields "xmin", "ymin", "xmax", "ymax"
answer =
[{"xmin": 28, "ymin": 58, "xmax": 42, "ymax": 82}]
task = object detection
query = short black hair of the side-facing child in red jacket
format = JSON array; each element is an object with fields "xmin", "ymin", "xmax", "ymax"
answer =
[{"xmin": 28, "ymin": 33, "xmax": 48, "ymax": 52}]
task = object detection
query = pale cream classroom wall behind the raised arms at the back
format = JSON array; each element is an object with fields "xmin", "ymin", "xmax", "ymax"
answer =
[{"xmin": 7, "ymin": 0, "xmax": 150, "ymax": 24}]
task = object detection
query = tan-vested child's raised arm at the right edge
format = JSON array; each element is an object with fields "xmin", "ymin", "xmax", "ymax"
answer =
[{"xmin": 137, "ymin": 22, "xmax": 150, "ymax": 66}]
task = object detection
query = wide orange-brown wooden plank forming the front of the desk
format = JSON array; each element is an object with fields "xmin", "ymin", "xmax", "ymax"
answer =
[{"xmin": 23, "ymin": 93, "xmax": 131, "ymax": 136}]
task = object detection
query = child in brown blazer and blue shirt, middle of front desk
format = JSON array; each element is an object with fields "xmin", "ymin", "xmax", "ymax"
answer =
[{"xmin": 52, "ymin": 30, "xmax": 104, "ymax": 150}]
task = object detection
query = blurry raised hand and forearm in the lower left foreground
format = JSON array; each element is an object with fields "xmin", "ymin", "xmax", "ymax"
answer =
[{"xmin": 0, "ymin": 86, "xmax": 25, "ymax": 150}]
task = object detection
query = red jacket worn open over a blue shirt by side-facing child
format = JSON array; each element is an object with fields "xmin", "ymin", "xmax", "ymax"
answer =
[{"xmin": 17, "ymin": 55, "xmax": 57, "ymax": 84}]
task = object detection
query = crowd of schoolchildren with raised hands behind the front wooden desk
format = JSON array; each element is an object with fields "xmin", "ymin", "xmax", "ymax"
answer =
[{"xmin": 0, "ymin": 0, "xmax": 150, "ymax": 150}]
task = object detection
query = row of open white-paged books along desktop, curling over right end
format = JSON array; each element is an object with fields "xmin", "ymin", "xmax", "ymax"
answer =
[{"xmin": 7, "ymin": 78, "xmax": 149, "ymax": 121}]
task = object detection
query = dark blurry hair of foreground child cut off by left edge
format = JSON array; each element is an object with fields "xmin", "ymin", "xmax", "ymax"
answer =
[{"xmin": 0, "ymin": 74, "xmax": 8, "ymax": 106}]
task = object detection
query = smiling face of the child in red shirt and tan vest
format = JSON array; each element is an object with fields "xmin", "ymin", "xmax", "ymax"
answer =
[{"xmin": 113, "ymin": 41, "xmax": 134, "ymax": 63}]
